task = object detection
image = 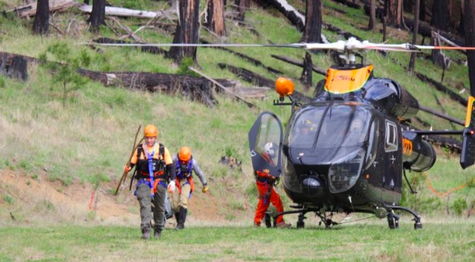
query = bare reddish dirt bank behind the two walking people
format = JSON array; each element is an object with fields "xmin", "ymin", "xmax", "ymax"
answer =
[{"xmin": 0, "ymin": 170, "xmax": 244, "ymax": 227}]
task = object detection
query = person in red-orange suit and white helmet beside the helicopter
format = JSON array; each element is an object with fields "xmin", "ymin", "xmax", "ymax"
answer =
[{"xmin": 254, "ymin": 143, "xmax": 290, "ymax": 227}]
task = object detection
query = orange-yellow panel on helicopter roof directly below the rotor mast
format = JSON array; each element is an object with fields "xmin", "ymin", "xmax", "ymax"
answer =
[{"xmin": 325, "ymin": 65, "xmax": 373, "ymax": 94}]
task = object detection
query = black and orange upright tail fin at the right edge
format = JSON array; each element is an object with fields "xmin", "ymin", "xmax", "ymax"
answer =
[{"xmin": 460, "ymin": 96, "xmax": 475, "ymax": 169}]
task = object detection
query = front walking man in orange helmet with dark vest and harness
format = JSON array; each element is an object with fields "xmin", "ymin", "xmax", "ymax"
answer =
[{"xmin": 124, "ymin": 125, "xmax": 175, "ymax": 239}]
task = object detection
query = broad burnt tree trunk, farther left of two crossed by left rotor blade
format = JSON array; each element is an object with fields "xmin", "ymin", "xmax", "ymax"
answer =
[{"xmin": 168, "ymin": 0, "xmax": 200, "ymax": 62}]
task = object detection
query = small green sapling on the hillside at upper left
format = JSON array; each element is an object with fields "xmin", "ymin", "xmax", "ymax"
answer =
[{"xmin": 39, "ymin": 43, "xmax": 91, "ymax": 107}]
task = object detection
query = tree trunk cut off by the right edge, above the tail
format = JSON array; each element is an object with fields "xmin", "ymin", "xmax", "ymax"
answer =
[{"xmin": 463, "ymin": 0, "xmax": 475, "ymax": 96}]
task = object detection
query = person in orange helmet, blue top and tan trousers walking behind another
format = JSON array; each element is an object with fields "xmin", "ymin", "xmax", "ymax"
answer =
[{"xmin": 172, "ymin": 146, "xmax": 208, "ymax": 229}]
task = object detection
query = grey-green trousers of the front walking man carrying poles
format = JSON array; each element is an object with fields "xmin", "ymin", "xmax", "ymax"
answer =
[{"xmin": 136, "ymin": 184, "xmax": 167, "ymax": 231}]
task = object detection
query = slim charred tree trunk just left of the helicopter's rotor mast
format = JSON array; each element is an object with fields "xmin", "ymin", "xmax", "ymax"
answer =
[{"xmin": 300, "ymin": 0, "xmax": 322, "ymax": 88}]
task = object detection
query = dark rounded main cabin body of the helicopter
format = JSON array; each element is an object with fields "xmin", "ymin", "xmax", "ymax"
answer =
[{"xmin": 282, "ymin": 102, "xmax": 403, "ymax": 214}]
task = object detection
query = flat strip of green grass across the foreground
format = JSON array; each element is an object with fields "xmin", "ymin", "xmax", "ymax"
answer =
[{"xmin": 0, "ymin": 221, "xmax": 475, "ymax": 261}]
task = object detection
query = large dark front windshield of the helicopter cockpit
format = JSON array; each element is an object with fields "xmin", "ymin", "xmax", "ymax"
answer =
[{"xmin": 288, "ymin": 104, "xmax": 371, "ymax": 164}]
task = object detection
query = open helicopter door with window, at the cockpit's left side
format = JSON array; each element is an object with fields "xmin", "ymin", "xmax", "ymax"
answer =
[{"xmin": 248, "ymin": 112, "xmax": 282, "ymax": 177}]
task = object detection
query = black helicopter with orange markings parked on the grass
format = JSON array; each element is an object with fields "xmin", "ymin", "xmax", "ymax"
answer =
[{"xmin": 248, "ymin": 39, "xmax": 475, "ymax": 229}]
